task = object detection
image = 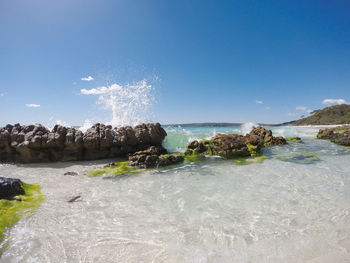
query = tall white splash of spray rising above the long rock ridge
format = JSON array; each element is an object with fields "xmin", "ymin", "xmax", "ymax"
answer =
[{"xmin": 80, "ymin": 80, "xmax": 154, "ymax": 127}]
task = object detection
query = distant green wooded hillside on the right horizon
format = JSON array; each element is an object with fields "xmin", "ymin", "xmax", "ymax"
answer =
[{"xmin": 289, "ymin": 104, "xmax": 350, "ymax": 125}]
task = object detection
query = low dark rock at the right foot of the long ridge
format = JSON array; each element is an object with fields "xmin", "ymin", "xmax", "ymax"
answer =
[{"xmin": 128, "ymin": 146, "xmax": 184, "ymax": 168}]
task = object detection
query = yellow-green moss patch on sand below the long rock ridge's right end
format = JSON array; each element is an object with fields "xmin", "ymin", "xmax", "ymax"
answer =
[{"xmin": 87, "ymin": 161, "xmax": 144, "ymax": 177}]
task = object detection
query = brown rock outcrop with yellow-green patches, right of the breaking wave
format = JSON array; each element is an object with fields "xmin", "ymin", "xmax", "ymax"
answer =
[{"xmin": 185, "ymin": 126, "xmax": 287, "ymax": 158}]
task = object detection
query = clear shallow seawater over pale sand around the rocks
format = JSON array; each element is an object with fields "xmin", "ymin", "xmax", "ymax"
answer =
[{"xmin": 0, "ymin": 127, "xmax": 350, "ymax": 263}]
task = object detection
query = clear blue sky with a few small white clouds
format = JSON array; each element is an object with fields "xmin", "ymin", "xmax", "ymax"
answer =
[{"xmin": 0, "ymin": 0, "xmax": 350, "ymax": 125}]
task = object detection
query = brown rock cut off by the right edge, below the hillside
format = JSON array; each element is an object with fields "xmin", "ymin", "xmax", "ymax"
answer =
[{"xmin": 317, "ymin": 125, "xmax": 350, "ymax": 146}]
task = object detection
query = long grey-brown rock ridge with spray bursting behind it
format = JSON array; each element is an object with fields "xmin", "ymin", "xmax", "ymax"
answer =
[{"xmin": 0, "ymin": 123, "xmax": 166, "ymax": 163}]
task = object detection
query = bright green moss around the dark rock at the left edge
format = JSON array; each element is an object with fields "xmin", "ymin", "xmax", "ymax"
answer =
[{"xmin": 0, "ymin": 183, "xmax": 45, "ymax": 246}]
